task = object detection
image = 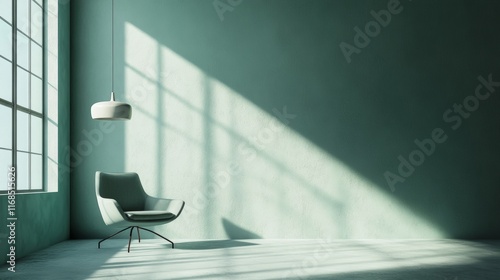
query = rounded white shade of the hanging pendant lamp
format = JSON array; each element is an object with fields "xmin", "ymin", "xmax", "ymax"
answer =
[{"xmin": 90, "ymin": 93, "xmax": 132, "ymax": 121}]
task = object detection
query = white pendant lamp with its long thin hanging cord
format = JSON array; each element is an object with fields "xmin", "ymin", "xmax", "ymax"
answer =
[{"xmin": 90, "ymin": 0, "xmax": 132, "ymax": 121}]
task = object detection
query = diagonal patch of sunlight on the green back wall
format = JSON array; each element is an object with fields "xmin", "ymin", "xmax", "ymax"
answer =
[{"xmin": 124, "ymin": 23, "xmax": 443, "ymax": 238}]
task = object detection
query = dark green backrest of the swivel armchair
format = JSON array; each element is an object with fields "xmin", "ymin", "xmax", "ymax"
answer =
[{"xmin": 95, "ymin": 171, "xmax": 146, "ymax": 211}]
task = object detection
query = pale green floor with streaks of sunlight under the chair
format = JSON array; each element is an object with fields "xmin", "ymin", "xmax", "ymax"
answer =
[{"xmin": 0, "ymin": 239, "xmax": 500, "ymax": 280}]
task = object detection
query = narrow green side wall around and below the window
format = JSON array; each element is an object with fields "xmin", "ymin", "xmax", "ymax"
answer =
[{"xmin": 0, "ymin": 0, "xmax": 70, "ymax": 268}]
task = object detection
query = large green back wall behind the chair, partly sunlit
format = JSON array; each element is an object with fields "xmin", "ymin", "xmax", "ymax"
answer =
[{"xmin": 71, "ymin": 0, "xmax": 500, "ymax": 239}]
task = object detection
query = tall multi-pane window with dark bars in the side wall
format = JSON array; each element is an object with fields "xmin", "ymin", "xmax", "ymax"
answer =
[{"xmin": 0, "ymin": 0, "xmax": 45, "ymax": 191}]
